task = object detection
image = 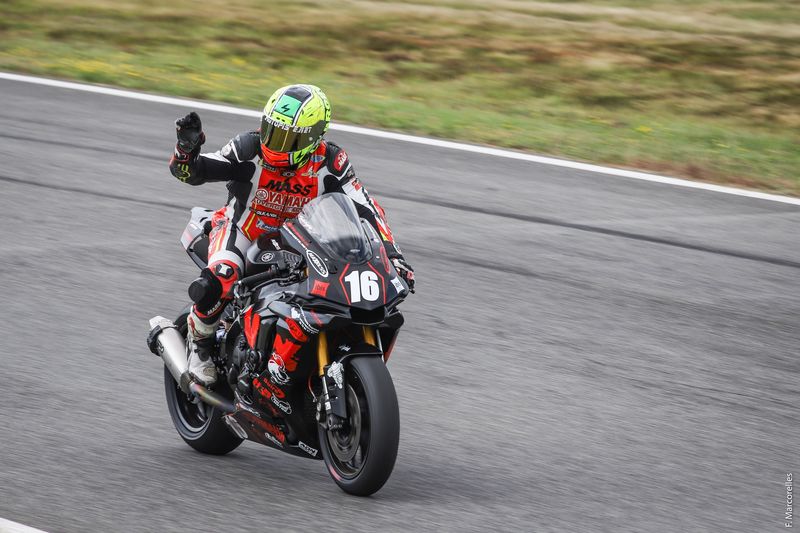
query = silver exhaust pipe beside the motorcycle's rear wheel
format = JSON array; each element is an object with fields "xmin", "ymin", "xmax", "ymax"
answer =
[{"xmin": 147, "ymin": 316, "xmax": 236, "ymax": 413}]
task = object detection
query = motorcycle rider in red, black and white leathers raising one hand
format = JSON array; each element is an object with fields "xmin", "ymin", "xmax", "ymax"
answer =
[{"xmin": 169, "ymin": 85, "xmax": 414, "ymax": 413}]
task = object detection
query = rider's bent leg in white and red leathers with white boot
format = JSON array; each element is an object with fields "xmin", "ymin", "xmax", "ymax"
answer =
[{"xmin": 186, "ymin": 214, "xmax": 250, "ymax": 386}]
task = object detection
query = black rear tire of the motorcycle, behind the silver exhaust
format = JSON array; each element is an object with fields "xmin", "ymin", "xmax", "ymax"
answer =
[{"xmin": 164, "ymin": 314, "xmax": 243, "ymax": 455}]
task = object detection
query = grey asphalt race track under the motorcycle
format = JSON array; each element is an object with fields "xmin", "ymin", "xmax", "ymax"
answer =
[{"xmin": 0, "ymin": 77, "xmax": 800, "ymax": 532}]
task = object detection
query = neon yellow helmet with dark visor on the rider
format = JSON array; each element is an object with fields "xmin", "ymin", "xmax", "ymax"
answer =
[{"xmin": 261, "ymin": 85, "xmax": 331, "ymax": 167}]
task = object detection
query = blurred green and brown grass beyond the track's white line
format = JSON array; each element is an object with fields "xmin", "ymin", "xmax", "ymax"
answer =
[{"xmin": 0, "ymin": 0, "xmax": 800, "ymax": 196}]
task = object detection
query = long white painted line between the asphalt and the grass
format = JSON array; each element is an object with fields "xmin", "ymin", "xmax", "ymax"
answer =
[{"xmin": 0, "ymin": 72, "xmax": 800, "ymax": 205}]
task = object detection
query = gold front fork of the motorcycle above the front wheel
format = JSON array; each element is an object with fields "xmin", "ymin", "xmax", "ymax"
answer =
[{"xmin": 317, "ymin": 326, "xmax": 380, "ymax": 429}]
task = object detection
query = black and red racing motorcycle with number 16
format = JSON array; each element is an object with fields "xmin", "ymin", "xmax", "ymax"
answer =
[{"xmin": 148, "ymin": 193, "xmax": 409, "ymax": 496}]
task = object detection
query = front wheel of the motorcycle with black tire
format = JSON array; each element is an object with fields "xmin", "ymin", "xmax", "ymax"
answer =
[{"xmin": 319, "ymin": 357, "xmax": 400, "ymax": 496}]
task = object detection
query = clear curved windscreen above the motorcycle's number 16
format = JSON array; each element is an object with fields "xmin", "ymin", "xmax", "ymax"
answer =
[{"xmin": 297, "ymin": 193, "xmax": 372, "ymax": 263}]
